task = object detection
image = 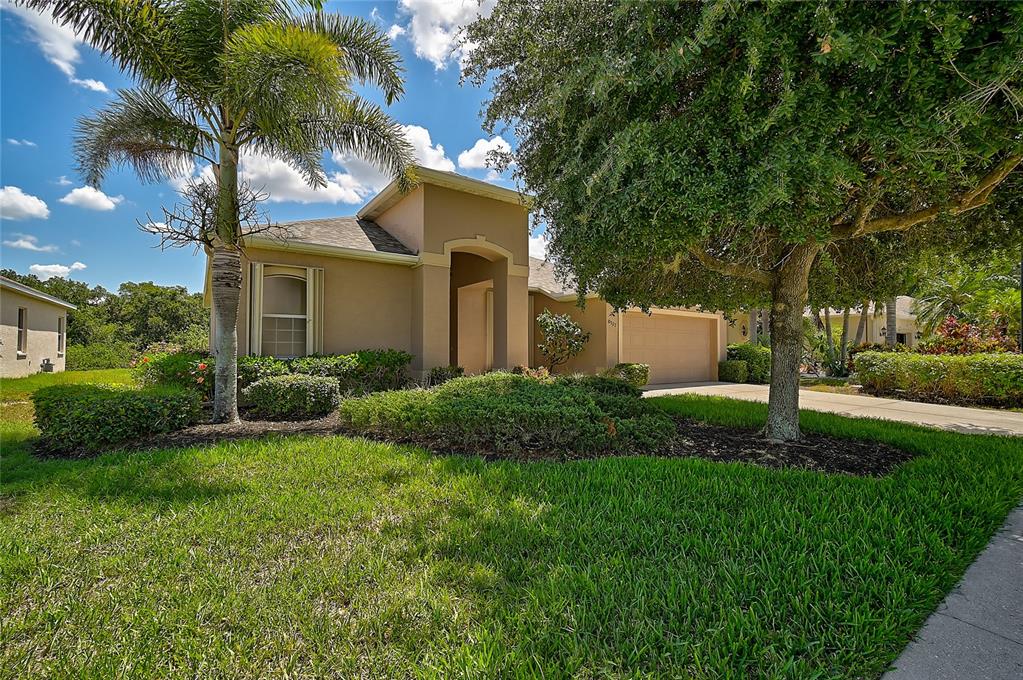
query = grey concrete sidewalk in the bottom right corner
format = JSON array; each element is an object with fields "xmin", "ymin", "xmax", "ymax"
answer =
[{"xmin": 883, "ymin": 505, "xmax": 1023, "ymax": 680}]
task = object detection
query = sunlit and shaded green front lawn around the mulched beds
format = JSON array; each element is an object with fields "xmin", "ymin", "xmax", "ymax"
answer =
[{"xmin": 0, "ymin": 390, "xmax": 1023, "ymax": 678}]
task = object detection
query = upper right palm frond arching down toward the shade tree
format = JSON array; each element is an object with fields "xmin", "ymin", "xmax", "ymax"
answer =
[{"xmin": 293, "ymin": 11, "xmax": 405, "ymax": 104}]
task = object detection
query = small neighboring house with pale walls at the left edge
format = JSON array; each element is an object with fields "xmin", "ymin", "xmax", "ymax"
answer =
[{"xmin": 0, "ymin": 276, "xmax": 76, "ymax": 377}]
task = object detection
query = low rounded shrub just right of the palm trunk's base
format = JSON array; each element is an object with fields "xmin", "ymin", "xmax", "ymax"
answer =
[{"xmin": 242, "ymin": 374, "xmax": 341, "ymax": 420}]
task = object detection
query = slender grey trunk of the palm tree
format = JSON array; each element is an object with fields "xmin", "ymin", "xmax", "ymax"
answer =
[{"xmin": 211, "ymin": 143, "xmax": 241, "ymax": 422}]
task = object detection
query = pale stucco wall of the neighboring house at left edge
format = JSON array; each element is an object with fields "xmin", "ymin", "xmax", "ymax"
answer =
[{"xmin": 0, "ymin": 288, "xmax": 68, "ymax": 377}]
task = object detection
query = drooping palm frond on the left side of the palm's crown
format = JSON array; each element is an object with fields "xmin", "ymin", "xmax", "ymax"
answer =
[{"xmin": 75, "ymin": 88, "xmax": 217, "ymax": 186}]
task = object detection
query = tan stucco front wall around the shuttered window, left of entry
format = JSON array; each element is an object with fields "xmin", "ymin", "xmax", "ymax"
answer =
[{"xmin": 238, "ymin": 248, "xmax": 413, "ymax": 354}]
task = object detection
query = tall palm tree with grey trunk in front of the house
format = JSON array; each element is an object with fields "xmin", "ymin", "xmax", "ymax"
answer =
[{"xmin": 26, "ymin": 0, "xmax": 415, "ymax": 422}]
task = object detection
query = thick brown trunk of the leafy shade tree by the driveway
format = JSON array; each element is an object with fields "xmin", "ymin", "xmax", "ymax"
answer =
[{"xmin": 764, "ymin": 242, "xmax": 820, "ymax": 442}]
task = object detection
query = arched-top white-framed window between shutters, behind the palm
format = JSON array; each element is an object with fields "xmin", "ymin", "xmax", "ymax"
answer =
[{"xmin": 260, "ymin": 274, "xmax": 307, "ymax": 357}]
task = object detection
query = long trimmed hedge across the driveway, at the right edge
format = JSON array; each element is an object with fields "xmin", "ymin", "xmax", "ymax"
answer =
[{"xmin": 854, "ymin": 352, "xmax": 1023, "ymax": 407}]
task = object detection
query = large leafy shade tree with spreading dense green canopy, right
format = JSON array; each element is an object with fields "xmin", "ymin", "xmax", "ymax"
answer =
[{"xmin": 464, "ymin": 0, "xmax": 1023, "ymax": 440}]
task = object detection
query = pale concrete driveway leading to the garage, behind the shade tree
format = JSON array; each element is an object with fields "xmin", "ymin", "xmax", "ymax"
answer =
[{"xmin": 646, "ymin": 382, "xmax": 1023, "ymax": 437}]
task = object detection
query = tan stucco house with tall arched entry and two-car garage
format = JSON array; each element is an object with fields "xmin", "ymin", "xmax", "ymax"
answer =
[{"xmin": 206, "ymin": 168, "xmax": 725, "ymax": 382}]
